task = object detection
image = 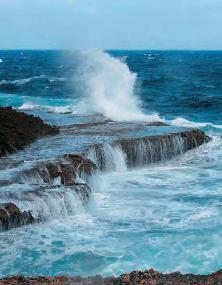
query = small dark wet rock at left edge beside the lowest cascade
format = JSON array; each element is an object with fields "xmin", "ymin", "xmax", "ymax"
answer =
[{"xmin": 0, "ymin": 203, "xmax": 34, "ymax": 231}]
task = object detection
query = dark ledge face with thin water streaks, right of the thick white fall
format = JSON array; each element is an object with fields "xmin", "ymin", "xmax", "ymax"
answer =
[{"xmin": 115, "ymin": 130, "xmax": 210, "ymax": 167}]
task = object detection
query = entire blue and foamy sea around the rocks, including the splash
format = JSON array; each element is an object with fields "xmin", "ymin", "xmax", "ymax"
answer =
[{"xmin": 0, "ymin": 50, "xmax": 222, "ymax": 277}]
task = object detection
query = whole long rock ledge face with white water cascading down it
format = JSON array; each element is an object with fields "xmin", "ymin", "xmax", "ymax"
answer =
[{"xmin": 0, "ymin": 127, "xmax": 210, "ymax": 230}]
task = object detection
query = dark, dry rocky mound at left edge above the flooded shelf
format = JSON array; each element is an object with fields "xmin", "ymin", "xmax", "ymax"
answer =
[{"xmin": 0, "ymin": 107, "xmax": 59, "ymax": 157}]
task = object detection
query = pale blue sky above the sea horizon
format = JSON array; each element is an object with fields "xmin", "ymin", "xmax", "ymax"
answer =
[{"xmin": 0, "ymin": 0, "xmax": 222, "ymax": 49}]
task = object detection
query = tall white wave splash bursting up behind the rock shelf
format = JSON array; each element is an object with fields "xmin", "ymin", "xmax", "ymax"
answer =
[{"xmin": 75, "ymin": 50, "xmax": 160, "ymax": 121}]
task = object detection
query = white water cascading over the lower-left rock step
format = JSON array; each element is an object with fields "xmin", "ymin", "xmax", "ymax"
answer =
[{"xmin": 0, "ymin": 184, "xmax": 85, "ymax": 221}]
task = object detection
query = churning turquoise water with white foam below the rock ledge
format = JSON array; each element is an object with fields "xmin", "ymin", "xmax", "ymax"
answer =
[{"xmin": 0, "ymin": 137, "xmax": 222, "ymax": 276}]
